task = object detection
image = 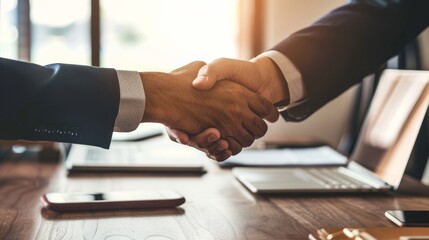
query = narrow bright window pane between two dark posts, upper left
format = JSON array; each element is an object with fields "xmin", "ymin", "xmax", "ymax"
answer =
[{"xmin": 30, "ymin": 0, "xmax": 91, "ymax": 65}]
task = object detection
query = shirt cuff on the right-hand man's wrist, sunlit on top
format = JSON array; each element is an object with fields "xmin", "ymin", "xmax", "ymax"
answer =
[{"xmin": 259, "ymin": 50, "xmax": 307, "ymax": 104}]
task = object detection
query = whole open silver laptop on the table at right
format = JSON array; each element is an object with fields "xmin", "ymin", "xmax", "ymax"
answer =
[{"xmin": 232, "ymin": 70, "xmax": 429, "ymax": 193}]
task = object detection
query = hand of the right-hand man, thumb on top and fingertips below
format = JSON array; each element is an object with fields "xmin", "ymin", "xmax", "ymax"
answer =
[{"xmin": 167, "ymin": 57, "xmax": 289, "ymax": 161}]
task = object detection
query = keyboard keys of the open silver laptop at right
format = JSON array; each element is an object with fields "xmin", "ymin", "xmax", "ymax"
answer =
[{"xmin": 305, "ymin": 168, "xmax": 372, "ymax": 189}]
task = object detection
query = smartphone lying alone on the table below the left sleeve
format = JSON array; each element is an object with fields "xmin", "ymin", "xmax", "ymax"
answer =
[{"xmin": 40, "ymin": 190, "xmax": 185, "ymax": 212}]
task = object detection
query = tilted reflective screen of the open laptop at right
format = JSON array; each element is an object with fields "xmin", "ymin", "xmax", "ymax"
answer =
[{"xmin": 351, "ymin": 70, "xmax": 429, "ymax": 187}]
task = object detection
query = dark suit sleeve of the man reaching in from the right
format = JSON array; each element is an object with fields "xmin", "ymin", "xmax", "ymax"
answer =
[{"xmin": 273, "ymin": 0, "xmax": 429, "ymax": 119}]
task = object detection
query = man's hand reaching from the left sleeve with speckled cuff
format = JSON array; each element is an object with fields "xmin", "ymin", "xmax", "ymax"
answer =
[{"xmin": 140, "ymin": 62, "xmax": 278, "ymax": 146}]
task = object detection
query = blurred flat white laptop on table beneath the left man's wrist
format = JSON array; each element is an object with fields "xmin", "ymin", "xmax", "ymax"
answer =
[{"xmin": 66, "ymin": 123, "xmax": 207, "ymax": 173}]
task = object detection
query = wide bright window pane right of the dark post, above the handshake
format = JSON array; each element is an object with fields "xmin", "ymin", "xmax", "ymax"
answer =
[{"xmin": 100, "ymin": 0, "xmax": 238, "ymax": 70}]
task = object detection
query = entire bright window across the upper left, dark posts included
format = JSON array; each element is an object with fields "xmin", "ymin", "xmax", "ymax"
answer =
[{"xmin": 0, "ymin": 0, "xmax": 253, "ymax": 71}]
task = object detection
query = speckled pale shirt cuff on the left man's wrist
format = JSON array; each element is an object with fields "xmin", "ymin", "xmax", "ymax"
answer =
[{"xmin": 113, "ymin": 70, "xmax": 146, "ymax": 132}]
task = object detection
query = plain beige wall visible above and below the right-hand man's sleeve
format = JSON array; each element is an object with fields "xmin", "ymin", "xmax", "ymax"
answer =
[{"xmin": 254, "ymin": 0, "xmax": 354, "ymax": 147}]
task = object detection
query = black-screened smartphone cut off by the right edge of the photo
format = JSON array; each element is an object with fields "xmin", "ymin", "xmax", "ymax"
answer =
[{"xmin": 384, "ymin": 210, "xmax": 429, "ymax": 227}]
